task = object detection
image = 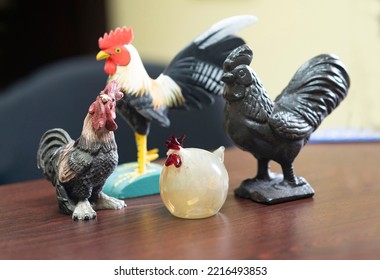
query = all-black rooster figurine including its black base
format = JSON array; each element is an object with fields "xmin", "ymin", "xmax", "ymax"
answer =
[{"xmin": 222, "ymin": 45, "xmax": 350, "ymax": 204}]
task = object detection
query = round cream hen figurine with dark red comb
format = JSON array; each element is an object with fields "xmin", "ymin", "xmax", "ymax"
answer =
[{"xmin": 160, "ymin": 136, "xmax": 228, "ymax": 219}]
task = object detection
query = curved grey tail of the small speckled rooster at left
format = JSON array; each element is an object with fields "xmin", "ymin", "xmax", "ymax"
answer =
[{"xmin": 37, "ymin": 128, "xmax": 72, "ymax": 183}]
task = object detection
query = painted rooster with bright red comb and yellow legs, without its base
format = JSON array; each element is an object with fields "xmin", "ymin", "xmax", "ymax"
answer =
[{"xmin": 96, "ymin": 15, "xmax": 256, "ymax": 174}]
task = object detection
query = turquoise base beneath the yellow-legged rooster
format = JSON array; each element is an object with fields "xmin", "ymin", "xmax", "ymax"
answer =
[{"xmin": 103, "ymin": 162, "xmax": 162, "ymax": 199}]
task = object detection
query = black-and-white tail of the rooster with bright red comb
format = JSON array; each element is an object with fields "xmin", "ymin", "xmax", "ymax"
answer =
[{"xmin": 163, "ymin": 15, "xmax": 256, "ymax": 108}]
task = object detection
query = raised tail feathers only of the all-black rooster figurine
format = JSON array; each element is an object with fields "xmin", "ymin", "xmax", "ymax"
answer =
[{"xmin": 275, "ymin": 54, "xmax": 350, "ymax": 130}]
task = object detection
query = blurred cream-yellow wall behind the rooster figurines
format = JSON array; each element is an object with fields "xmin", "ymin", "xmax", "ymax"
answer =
[{"xmin": 107, "ymin": 0, "xmax": 380, "ymax": 131}]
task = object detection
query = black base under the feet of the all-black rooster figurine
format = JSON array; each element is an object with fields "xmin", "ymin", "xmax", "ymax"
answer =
[{"xmin": 235, "ymin": 173, "xmax": 314, "ymax": 205}]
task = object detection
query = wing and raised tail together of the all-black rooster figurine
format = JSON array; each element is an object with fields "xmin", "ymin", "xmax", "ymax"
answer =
[{"xmin": 268, "ymin": 54, "xmax": 350, "ymax": 140}]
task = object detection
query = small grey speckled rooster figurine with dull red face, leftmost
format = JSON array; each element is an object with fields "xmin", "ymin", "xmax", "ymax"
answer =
[{"xmin": 37, "ymin": 82, "xmax": 126, "ymax": 220}]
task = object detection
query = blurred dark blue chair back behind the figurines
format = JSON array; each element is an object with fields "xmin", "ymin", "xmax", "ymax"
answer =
[{"xmin": 0, "ymin": 55, "xmax": 231, "ymax": 185}]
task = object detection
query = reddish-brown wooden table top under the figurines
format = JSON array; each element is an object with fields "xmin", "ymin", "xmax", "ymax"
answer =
[{"xmin": 0, "ymin": 143, "xmax": 380, "ymax": 259}]
